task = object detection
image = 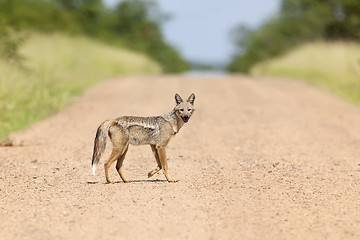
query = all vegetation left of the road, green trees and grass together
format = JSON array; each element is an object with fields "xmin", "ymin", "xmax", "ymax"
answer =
[{"xmin": 0, "ymin": 0, "xmax": 188, "ymax": 140}]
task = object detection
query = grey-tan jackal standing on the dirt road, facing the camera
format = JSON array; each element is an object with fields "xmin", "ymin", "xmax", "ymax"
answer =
[{"xmin": 92, "ymin": 94, "xmax": 195, "ymax": 183}]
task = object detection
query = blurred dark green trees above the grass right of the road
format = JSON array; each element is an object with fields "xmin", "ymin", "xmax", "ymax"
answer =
[{"xmin": 227, "ymin": 0, "xmax": 360, "ymax": 73}]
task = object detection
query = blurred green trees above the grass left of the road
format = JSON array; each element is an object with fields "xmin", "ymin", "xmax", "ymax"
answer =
[{"xmin": 0, "ymin": 0, "xmax": 189, "ymax": 72}]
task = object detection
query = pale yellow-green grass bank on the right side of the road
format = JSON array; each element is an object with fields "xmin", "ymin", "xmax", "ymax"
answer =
[{"xmin": 251, "ymin": 42, "xmax": 360, "ymax": 104}]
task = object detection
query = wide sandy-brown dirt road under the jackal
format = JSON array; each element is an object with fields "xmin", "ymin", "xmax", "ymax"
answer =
[{"xmin": 0, "ymin": 76, "xmax": 360, "ymax": 240}]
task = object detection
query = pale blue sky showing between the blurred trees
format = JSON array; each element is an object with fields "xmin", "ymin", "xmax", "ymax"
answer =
[{"xmin": 105, "ymin": 0, "xmax": 280, "ymax": 63}]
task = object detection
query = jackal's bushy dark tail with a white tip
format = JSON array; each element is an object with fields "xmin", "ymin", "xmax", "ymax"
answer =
[{"xmin": 91, "ymin": 120, "xmax": 114, "ymax": 175}]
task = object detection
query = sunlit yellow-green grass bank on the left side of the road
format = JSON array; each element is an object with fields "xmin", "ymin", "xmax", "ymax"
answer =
[{"xmin": 0, "ymin": 34, "xmax": 161, "ymax": 139}]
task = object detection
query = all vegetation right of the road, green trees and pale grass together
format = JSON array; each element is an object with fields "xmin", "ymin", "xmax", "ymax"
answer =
[{"xmin": 227, "ymin": 0, "xmax": 360, "ymax": 103}]
